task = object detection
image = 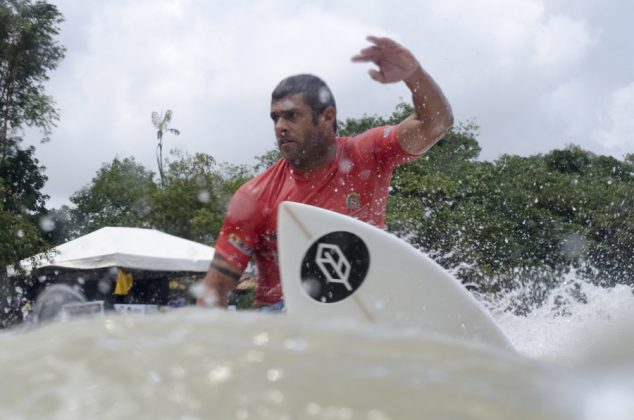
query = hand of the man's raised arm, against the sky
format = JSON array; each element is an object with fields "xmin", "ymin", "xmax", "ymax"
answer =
[{"xmin": 352, "ymin": 36, "xmax": 420, "ymax": 83}]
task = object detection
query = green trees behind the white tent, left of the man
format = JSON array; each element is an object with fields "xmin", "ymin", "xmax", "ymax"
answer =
[{"xmin": 63, "ymin": 151, "xmax": 242, "ymax": 244}]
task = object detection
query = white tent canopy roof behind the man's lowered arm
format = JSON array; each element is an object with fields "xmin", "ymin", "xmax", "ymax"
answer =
[{"xmin": 8, "ymin": 227, "xmax": 214, "ymax": 276}]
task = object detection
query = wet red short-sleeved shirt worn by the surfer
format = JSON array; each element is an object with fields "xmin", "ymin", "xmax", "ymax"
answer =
[{"xmin": 215, "ymin": 126, "xmax": 418, "ymax": 304}]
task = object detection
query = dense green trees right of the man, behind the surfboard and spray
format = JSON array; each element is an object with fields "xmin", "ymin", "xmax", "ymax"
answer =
[{"xmin": 388, "ymin": 130, "xmax": 634, "ymax": 293}]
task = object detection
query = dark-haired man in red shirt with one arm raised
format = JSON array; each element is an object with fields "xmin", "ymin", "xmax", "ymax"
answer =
[{"xmin": 199, "ymin": 36, "xmax": 453, "ymax": 309}]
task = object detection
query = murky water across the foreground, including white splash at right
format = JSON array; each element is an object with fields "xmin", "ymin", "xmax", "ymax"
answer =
[{"xmin": 0, "ymin": 278, "xmax": 634, "ymax": 420}]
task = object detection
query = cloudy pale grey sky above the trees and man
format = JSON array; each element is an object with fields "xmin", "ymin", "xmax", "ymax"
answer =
[{"xmin": 26, "ymin": 0, "xmax": 634, "ymax": 208}]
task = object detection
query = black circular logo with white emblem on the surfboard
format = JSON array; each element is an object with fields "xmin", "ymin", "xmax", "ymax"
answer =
[{"xmin": 301, "ymin": 231, "xmax": 370, "ymax": 303}]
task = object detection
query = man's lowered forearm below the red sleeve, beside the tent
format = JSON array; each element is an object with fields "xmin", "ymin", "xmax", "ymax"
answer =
[{"xmin": 197, "ymin": 252, "xmax": 243, "ymax": 308}]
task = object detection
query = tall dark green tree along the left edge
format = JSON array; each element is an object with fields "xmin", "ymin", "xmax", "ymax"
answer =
[{"xmin": 0, "ymin": 0, "xmax": 65, "ymax": 322}]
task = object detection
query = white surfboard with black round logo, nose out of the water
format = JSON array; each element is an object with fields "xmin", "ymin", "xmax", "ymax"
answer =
[{"xmin": 278, "ymin": 202, "xmax": 511, "ymax": 348}]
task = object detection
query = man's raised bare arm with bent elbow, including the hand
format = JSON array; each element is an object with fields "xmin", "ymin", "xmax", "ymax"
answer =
[{"xmin": 352, "ymin": 36, "xmax": 453, "ymax": 155}]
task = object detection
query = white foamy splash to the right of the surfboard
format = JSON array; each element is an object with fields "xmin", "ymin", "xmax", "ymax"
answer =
[{"xmin": 483, "ymin": 274, "xmax": 634, "ymax": 364}]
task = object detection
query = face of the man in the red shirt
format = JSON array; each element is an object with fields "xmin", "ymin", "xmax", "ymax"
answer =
[{"xmin": 271, "ymin": 93, "xmax": 335, "ymax": 171}]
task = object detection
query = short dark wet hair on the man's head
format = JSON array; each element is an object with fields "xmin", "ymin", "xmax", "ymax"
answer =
[{"xmin": 271, "ymin": 74, "xmax": 337, "ymax": 132}]
